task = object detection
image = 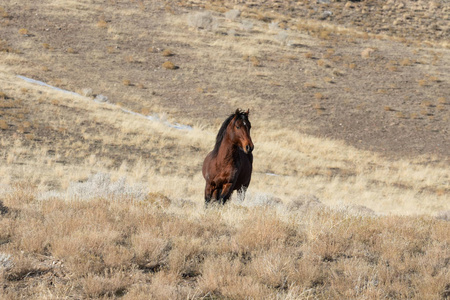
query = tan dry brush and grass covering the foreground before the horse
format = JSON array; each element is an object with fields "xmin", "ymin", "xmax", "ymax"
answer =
[{"xmin": 0, "ymin": 183, "xmax": 450, "ymax": 299}]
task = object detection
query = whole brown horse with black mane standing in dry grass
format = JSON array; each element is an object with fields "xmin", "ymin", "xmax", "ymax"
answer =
[{"xmin": 203, "ymin": 109, "xmax": 253, "ymax": 205}]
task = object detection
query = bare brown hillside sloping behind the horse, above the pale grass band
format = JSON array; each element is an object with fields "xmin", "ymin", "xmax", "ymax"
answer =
[{"xmin": 0, "ymin": 1, "xmax": 450, "ymax": 160}]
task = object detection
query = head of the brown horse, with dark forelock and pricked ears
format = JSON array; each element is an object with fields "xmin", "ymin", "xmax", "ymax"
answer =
[{"xmin": 228, "ymin": 109, "xmax": 254, "ymax": 154}]
